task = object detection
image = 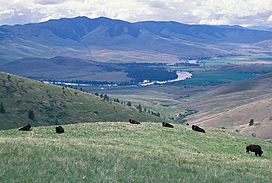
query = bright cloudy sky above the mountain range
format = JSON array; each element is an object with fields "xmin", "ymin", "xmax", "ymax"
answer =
[{"xmin": 0, "ymin": 0, "xmax": 272, "ymax": 26}]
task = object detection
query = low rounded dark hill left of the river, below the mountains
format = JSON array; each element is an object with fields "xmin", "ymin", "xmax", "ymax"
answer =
[{"xmin": 0, "ymin": 56, "xmax": 131, "ymax": 82}]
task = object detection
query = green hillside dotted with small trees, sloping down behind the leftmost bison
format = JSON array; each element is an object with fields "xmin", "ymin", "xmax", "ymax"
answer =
[{"xmin": 0, "ymin": 73, "xmax": 161, "ymax": 129}]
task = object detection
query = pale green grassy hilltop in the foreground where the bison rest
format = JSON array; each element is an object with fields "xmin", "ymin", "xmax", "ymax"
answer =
[{"xmin": 0, "ymin": 122, "xmax": 272, "ymax": 183}]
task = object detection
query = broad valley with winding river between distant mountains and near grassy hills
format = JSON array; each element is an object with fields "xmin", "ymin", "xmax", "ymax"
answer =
[{"xmin": 0, "ymin": 44, "xmax": 272, "ymax": 139}]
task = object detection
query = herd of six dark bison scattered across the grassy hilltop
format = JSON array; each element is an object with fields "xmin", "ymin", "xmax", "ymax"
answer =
[{"xmin": 18, "ymin": 119, "xmax": 263, "ymax": 156}]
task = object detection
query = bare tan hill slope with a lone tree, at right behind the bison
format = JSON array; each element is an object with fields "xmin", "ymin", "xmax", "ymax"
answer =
[{"xmin": 184, "ymin": 73, "xmax": 272, "ymax": 139}]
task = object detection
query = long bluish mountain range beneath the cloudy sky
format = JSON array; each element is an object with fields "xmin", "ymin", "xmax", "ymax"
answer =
[{"xmin": 0, "ymin": 17, "xmax": 272, "ymax": 62}]
